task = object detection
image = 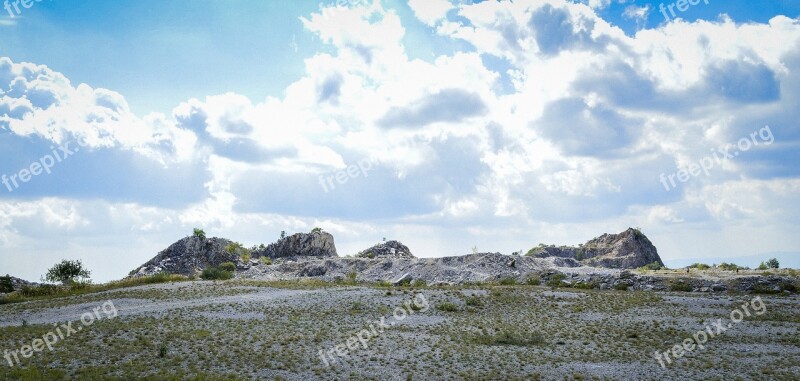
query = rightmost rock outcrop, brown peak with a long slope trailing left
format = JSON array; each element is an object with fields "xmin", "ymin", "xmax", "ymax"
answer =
[{"xmin": 528, "ymin": 228, "xmax": 664, "ymax": 269}]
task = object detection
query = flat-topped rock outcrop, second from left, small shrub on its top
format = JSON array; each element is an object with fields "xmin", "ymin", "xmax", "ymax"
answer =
[{"xmin": 252, "ymin": 229, "xmax": 337, "ymax": 259}]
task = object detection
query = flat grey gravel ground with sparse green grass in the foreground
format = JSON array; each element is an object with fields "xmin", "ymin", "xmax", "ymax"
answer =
[{"xmin": 0, "ymin": 281, "xmax": 800, "ymax": 380}]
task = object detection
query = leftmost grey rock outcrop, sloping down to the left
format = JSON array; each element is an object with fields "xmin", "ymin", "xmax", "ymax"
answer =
[{"xmin": 130, "ymin": 236, "xmax": 238, "ymax": 277}]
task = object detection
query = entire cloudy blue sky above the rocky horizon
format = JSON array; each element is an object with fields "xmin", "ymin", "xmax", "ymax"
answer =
[{"xmin": 0, "ymin": 0, "xmax": 800, "ymax": 282}]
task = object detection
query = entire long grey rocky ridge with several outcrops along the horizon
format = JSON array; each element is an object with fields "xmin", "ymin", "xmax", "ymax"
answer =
[{"xmin": 131, "ymin": 229, "xmax": 662, "ymax": 284}]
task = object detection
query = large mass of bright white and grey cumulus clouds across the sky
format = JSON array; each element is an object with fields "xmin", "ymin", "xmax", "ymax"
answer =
[{"xmin": 0, "ymin": 0, "xmax": 800, "ymax": 280}]
